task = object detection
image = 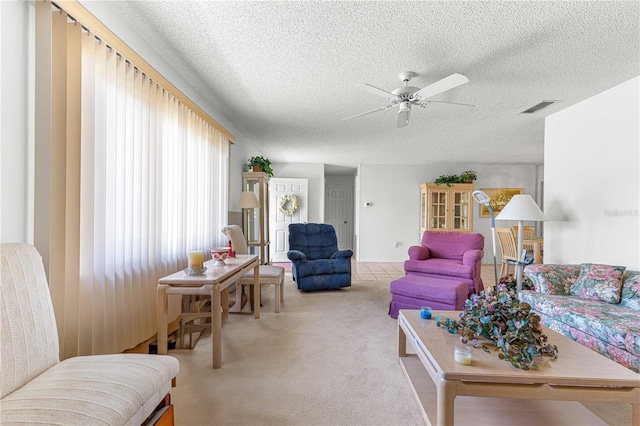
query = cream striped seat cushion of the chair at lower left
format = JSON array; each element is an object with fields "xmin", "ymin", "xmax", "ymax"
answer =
[{"xmin": 0, "ymin": 354, "xmax": 179, "ymax": 425}]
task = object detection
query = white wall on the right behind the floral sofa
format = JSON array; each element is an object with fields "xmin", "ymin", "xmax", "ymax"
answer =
[{"xmin": 544, "ymin": 77, "xmax": 640, "ymax": 270}]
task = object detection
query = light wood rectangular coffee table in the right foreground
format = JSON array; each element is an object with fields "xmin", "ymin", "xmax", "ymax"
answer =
[{"xmin": 398, "ymin": 310, "xmax": 640, "ymax": 426}]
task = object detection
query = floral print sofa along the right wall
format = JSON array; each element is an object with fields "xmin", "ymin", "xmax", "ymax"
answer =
[{"xmin": 521, "ymin": 263, "xmax": 640, "ymax": 372}]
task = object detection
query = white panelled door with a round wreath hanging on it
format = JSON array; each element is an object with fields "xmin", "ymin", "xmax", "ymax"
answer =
[{"xmin": 269, "ymin": 178, "xmax": 309, "ymax": 262}]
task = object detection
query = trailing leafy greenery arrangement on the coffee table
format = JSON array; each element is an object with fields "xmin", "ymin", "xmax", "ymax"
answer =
[{"xmin": 436, "ymin": 284, "xmax": 558, "ymax": 370}]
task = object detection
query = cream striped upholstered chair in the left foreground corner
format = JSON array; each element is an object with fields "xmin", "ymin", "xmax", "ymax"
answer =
[{"xmin": 0, "ymin": 244, "xmax": 179, "ymax": 425}]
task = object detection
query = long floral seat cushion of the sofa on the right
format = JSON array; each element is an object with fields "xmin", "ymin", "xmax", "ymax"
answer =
[{"xmin": 520, "ymin": 291, "xmax": 640, "ymax": 357}]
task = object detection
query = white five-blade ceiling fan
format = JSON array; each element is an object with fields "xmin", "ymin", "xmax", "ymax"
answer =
[{"xmin": 342, "ymin": 71, "xmax": 475, "ymax": 127}]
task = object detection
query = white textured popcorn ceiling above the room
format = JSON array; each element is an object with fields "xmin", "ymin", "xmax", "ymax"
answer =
[{"xmin": 102, "ymin": 1, "xmax": 640, "ymax": 165}]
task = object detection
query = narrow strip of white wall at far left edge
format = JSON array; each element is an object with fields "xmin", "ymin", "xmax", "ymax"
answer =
[{"xmin": 0, "ymin": 1, "xmax": 33, "ymax": 243}]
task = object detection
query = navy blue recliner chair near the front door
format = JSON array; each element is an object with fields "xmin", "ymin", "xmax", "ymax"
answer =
[{"xmin": 287, "ymin": 223, "xmax": 353, "ymax": 290}]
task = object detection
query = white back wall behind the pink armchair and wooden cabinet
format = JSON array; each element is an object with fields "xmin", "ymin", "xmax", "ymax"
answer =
[{"xmin": 355, "ymin": 164, "xmax": 538, "ymax": 263}]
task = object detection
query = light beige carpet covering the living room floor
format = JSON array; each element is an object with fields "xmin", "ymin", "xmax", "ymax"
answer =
[{"xmin": 169, "ymin": 275, "xmax": 631, "ymax": 426}]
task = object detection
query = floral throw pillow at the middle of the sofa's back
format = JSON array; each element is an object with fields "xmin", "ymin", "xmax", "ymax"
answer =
[{"xmin": 571, "ymin": 263, "xmax": 626, "ymax": 303}]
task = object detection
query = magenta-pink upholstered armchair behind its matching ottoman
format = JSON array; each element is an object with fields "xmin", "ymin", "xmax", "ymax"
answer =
[{"xmin": 404, "ymin": 231, "xmax": 484, "ymax": 294}]
